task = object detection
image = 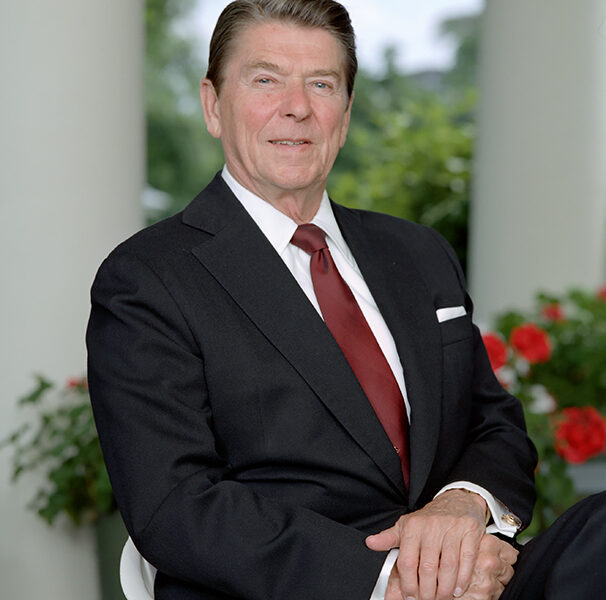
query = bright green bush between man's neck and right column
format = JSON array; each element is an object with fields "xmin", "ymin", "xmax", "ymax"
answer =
[{"xmin": 329, "ymin": 93, "xmax": 475, "ymax": 265}]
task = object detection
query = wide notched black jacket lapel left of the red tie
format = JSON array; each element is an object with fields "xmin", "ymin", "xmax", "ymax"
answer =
[{"xmin": 183, "ymin": 177, "xmax": 404, "ymax": 494}]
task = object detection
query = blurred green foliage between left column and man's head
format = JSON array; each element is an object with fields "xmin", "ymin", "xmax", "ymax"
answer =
[{"xmin": 145, "ymin": 0, "xmax": 223, "ymax": 220}]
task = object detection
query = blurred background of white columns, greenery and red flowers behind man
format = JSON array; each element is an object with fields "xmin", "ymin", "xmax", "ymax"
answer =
[{"xmin": 0, "ymin": 0, "xmax": 606, "ymax": 600}]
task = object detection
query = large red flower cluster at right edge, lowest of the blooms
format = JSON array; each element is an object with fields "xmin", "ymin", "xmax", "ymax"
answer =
[{"xmin": 554, "ymin": 406, "xmax": 606, "ymax": 463}]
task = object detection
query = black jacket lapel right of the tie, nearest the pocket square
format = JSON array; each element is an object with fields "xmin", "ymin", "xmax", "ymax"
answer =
[{"xmin": 333, "ymin": 205, "xmax": 442, "ymax": 507}]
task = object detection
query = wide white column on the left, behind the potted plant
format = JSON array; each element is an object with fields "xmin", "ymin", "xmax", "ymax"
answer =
[{"xmin": 0, "ymin": 0, "xmax": 144, "ymax": 600}]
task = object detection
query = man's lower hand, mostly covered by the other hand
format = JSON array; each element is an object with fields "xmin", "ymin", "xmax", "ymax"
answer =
[{"xmin": 460, "ymin": 535, "xmax": 518, "ymax": 600}]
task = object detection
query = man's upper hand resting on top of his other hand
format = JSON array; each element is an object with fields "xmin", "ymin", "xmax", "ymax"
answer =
[{"xmin": 366, "ymin": 490, "xmax": 490, "ymax": 600}]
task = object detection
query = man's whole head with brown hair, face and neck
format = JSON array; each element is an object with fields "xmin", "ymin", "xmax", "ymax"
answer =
[{"xmin": 200, "ymin": 0, "xmax": 356, "ymax": 216}]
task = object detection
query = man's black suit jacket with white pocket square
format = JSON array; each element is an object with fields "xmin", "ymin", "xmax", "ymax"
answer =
[{"xmin": 88, "ymin": 176, "xmax": 535, "ymax": 600}]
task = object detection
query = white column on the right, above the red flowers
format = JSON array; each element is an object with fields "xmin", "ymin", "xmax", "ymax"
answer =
[{"xmin": 470, "ymin": 0, "xmax": 606, "ymax": 321}]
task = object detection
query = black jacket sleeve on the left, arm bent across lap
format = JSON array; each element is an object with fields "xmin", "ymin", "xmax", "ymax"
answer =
[{"xmin": 87, "ymin": 251, "xmax": 386, "ymax": 600}]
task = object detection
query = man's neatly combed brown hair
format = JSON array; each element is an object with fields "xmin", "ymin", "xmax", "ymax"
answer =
[{"xmin": 206, "ymin": 0, "xmax": 358, "ymax": 97}]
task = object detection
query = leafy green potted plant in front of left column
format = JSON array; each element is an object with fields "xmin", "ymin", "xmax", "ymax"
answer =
[{"xmin": 0, "ymin": 376, "xmax": 116, "ymax": 524}]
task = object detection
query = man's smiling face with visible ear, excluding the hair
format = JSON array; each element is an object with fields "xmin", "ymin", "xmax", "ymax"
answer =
[{"xmin": 201, "ymin": 21, "xmax": 351, "ymax": 202}]
